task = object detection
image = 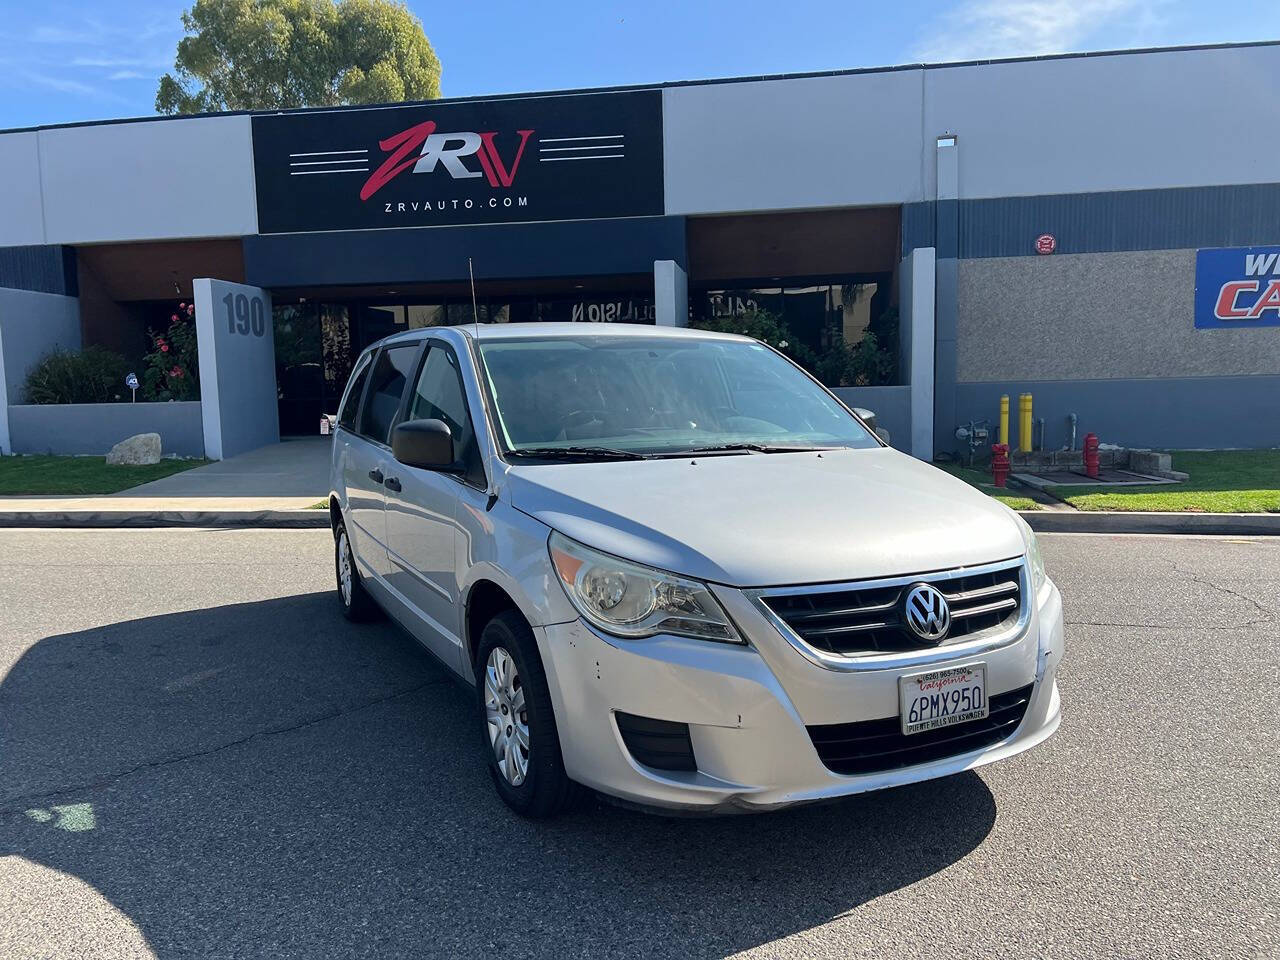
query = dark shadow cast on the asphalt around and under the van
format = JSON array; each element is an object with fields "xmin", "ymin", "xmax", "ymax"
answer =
[{"xmin": 0, "ymin": 594, "xmax": 996, "ymax": 960}]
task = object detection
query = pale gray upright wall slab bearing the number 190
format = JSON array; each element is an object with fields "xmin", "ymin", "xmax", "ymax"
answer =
[{"xmin": 192, "ymin": 279, "xmax": 280, "ymax": 460}]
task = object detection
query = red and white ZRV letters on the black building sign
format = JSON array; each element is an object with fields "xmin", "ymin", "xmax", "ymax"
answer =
[{"xmin": 360, "ymin": 120, "xmax": 532, "ymax": 200}]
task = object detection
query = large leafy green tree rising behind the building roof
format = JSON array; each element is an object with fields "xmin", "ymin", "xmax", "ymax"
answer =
[{"xmin": 156, "ymin": 0, "xmax": 440, "ymax": 114}]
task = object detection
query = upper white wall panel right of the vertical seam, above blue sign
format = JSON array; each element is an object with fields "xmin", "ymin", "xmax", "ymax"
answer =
[{"xmin": 924, "ymin": 46, "xmax": 1280, "ymax": 198}]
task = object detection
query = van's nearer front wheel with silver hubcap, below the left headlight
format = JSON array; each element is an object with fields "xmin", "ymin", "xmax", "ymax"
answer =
[{"xmin": 475, "ymin": 611, "xmax": 581, "ymax": 819}]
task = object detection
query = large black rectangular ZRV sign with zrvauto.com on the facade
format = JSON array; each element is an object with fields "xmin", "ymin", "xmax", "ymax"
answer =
[{"xmin": 253, "ymin": 90, "xmax": 663, "ymax": 233}]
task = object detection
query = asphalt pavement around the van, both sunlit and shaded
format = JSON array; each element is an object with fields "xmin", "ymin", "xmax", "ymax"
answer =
[{"xmin": 0, "ymin": 530, "xmax": 1280, "ymax": 960}]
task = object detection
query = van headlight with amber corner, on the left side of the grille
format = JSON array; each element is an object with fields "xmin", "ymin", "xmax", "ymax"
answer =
[{"xmin": 548, "ymin": 532, "xmax": 742, "ymax": 644}]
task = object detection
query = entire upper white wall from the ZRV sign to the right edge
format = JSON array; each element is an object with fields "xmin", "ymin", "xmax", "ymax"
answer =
[{"xmin": 663, "ymin": 46, "xmax": 1280, "ymax": 214}]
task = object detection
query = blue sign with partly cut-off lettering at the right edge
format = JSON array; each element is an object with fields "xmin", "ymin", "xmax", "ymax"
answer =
[{"xmin": 1196, "ymin": 247, "xmax": 1280, "ymax": 330}]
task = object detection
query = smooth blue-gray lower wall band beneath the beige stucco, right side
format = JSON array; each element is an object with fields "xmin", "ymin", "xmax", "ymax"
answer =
[{"xmin": 957, "ymin": 375, "xmax": 1280, "ymax": 449}]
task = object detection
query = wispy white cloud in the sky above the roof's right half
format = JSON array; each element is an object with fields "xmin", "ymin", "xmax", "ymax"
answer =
[{"xmin": 916, "ymin": 0, "xmax": 1164, "ymax": 61}]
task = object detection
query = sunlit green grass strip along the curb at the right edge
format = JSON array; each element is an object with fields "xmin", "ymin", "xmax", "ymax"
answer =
[{"xmin": 1050, "ymin": 451, "xmax": 1280, "ymax": 513}]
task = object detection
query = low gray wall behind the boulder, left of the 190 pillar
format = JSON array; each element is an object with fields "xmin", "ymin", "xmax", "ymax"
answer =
[{"xmin": 9, "ymin": 401, "xmax": 205, "ymax": 457}]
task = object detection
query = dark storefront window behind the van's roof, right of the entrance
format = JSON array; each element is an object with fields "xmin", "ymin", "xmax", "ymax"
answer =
[{"xmin": 690, "ymin": 275, "xmax": 897, "ymax": 387}]
